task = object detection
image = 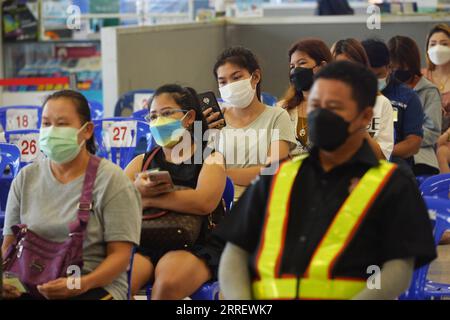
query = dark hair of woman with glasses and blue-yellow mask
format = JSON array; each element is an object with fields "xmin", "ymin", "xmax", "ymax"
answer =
[{"xmin": 147, "ymin": 84, "xmax": 208, "ymax": 149}]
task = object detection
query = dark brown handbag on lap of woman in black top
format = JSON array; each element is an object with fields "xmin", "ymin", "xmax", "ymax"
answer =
[{"xmin": 140, "ymin": 148, "xmax": 224, "ymax": 252}]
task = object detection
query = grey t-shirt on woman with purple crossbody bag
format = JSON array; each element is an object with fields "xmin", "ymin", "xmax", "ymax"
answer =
[{"xmin": 3, "ymin": 159, "xmax": 142, "ymax": 299}]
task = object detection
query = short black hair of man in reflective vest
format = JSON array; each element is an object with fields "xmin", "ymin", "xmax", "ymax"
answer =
[{"xmin": 315, "ymin": 61, "xmax": 378, "ymax": 111}]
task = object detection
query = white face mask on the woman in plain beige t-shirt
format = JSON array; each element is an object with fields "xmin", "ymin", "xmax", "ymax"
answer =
[{"xmin": 219, "ymin": 77, "xmax": 256, "ymax": 109}]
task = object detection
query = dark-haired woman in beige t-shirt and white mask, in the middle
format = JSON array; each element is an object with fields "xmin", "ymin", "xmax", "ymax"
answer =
[{"xmin": 208, "ymin": 47, "xmax": 296, "ymax": 198}]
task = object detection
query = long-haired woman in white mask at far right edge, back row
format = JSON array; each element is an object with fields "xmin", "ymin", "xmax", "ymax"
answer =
[{"xmin": 422, "ymin": 23, "xmax": 450, "ymax": 132}]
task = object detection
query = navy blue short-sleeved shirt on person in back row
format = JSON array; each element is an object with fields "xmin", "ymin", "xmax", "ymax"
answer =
[{"xmin": 382, "ymin": 77, "xmax": 425, "ymax": 162}]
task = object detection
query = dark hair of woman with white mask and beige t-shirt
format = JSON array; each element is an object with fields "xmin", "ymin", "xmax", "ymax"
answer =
[{"xmin": 214, "ymin": 46, "xmax": 262, "ymax": 101}]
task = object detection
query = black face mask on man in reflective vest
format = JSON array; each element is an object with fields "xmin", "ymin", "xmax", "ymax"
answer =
[{"xmin": 308, "ymin": 108, "xmax": 350, "ymax": 151}]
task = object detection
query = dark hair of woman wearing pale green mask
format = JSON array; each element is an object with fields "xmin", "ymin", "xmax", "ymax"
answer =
[{"xmin": 43, "ymin": 90, "xmax": 97, "ymax": 154}]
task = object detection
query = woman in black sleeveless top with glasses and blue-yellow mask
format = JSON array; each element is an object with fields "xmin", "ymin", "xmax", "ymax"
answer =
[{"xmin": 125, "ymin": 85, "xmax": 226, "ymax": 300}]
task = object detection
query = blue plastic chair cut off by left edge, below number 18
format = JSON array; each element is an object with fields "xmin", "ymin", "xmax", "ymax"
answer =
[{"xmin": 0, "ymin": 143, "xmax": 20, "ymax": 229}]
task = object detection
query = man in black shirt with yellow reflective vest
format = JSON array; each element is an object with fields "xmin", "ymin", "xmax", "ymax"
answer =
[{"xmin": 217, "ymin": 62, "xmax": 436, "ymax": 300}]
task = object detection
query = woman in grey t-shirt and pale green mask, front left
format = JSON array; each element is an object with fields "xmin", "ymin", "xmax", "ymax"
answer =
[{"xmin": 2, "ymin": 90, "xmax": 142, "ymax": 300}]
